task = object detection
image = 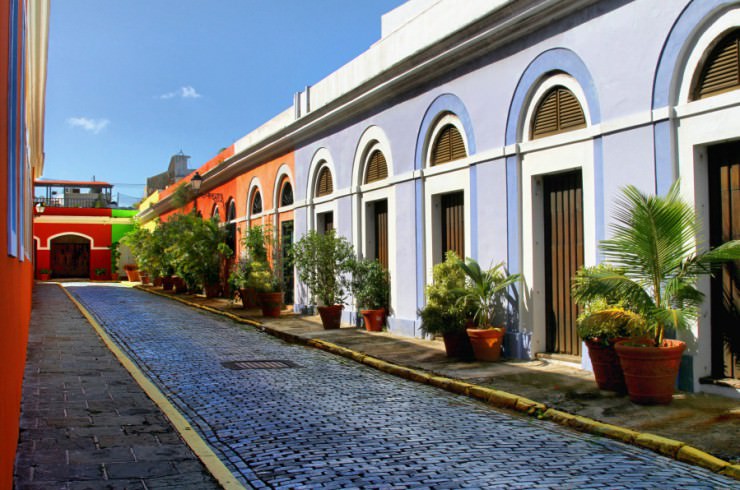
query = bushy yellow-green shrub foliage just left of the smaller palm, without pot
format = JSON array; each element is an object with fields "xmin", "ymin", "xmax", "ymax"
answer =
[{"xmin": 417, "ymin": 251, "xmax": 474, "ymax": 335}]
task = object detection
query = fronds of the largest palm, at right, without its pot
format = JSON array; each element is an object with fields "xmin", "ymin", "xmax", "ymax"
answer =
[{"xmin": 573, "ymin": 182, "xmax": 740, "ymax": 346}]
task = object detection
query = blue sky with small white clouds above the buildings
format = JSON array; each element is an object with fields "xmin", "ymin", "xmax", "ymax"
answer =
[{"xmin": 43, "ymin": 0, "xmax": 403, "ymax": 204}]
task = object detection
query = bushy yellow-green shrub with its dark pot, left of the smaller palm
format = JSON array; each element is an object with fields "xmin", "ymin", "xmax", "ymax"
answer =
[{"xmin": 417, "ymin": 251, "xmax": 474, "ymax": 360}]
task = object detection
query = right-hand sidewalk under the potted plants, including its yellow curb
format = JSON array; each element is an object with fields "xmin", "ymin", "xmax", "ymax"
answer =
[{"xmin": 141, "ymin": 286, "xmax": 740, "ymax": 479}]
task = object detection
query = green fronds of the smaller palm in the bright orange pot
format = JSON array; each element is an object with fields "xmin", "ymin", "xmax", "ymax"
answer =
[{"xmin": 457, "ymin": 257, "xmax": 520, "ymax": 328}]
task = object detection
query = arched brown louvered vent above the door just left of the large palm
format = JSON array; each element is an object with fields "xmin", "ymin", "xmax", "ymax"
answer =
[{"xmin": 532, "ymin": 86, "xmax": 586, "ymax": 139}]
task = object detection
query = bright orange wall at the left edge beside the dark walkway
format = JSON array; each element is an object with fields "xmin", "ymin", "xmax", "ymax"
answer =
[{"xmin": 0, "ymin": 0, "xmax": 33, "ymax": 488}]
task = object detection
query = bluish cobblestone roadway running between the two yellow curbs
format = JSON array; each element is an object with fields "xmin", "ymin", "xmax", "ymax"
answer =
[{"xmin": 68, "ymin": 285, "xmax": 737, "ymax": 489}]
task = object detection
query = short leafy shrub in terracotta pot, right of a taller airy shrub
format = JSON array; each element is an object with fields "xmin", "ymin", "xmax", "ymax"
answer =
[{"xmin": 349, "ymin": 259, "xmax": 390, "ymax": 332}]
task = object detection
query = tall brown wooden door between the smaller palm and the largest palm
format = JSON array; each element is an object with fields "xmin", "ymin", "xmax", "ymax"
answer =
[{"xmin": 543, "ymin": 170, "xmax": 583, "ymax": 356}]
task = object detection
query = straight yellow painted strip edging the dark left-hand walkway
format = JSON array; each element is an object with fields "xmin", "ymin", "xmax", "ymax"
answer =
[{"xmin": 58, "ymin": 284, "xmax": 246, "ymax": 490}]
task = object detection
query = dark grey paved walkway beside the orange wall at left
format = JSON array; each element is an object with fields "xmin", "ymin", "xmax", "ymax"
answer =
[{"xmin": 14, "ymin": 284, "xmax": 219, "ymax": 490}]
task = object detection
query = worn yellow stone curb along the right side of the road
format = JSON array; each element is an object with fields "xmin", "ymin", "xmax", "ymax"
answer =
[{"xmin": 134, "ymin": 286, "xmax": 740, "ymax": 481}]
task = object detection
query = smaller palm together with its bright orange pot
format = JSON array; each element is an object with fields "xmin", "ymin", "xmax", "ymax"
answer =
[{"xmin": 458, "ymin": 258, "xmax": 519, "ymax": 361}]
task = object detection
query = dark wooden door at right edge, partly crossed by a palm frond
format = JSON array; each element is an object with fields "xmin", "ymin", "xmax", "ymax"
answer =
[{"xmin": 708, "ymin": 142, "xmax": 740, "ymax": 379}]
